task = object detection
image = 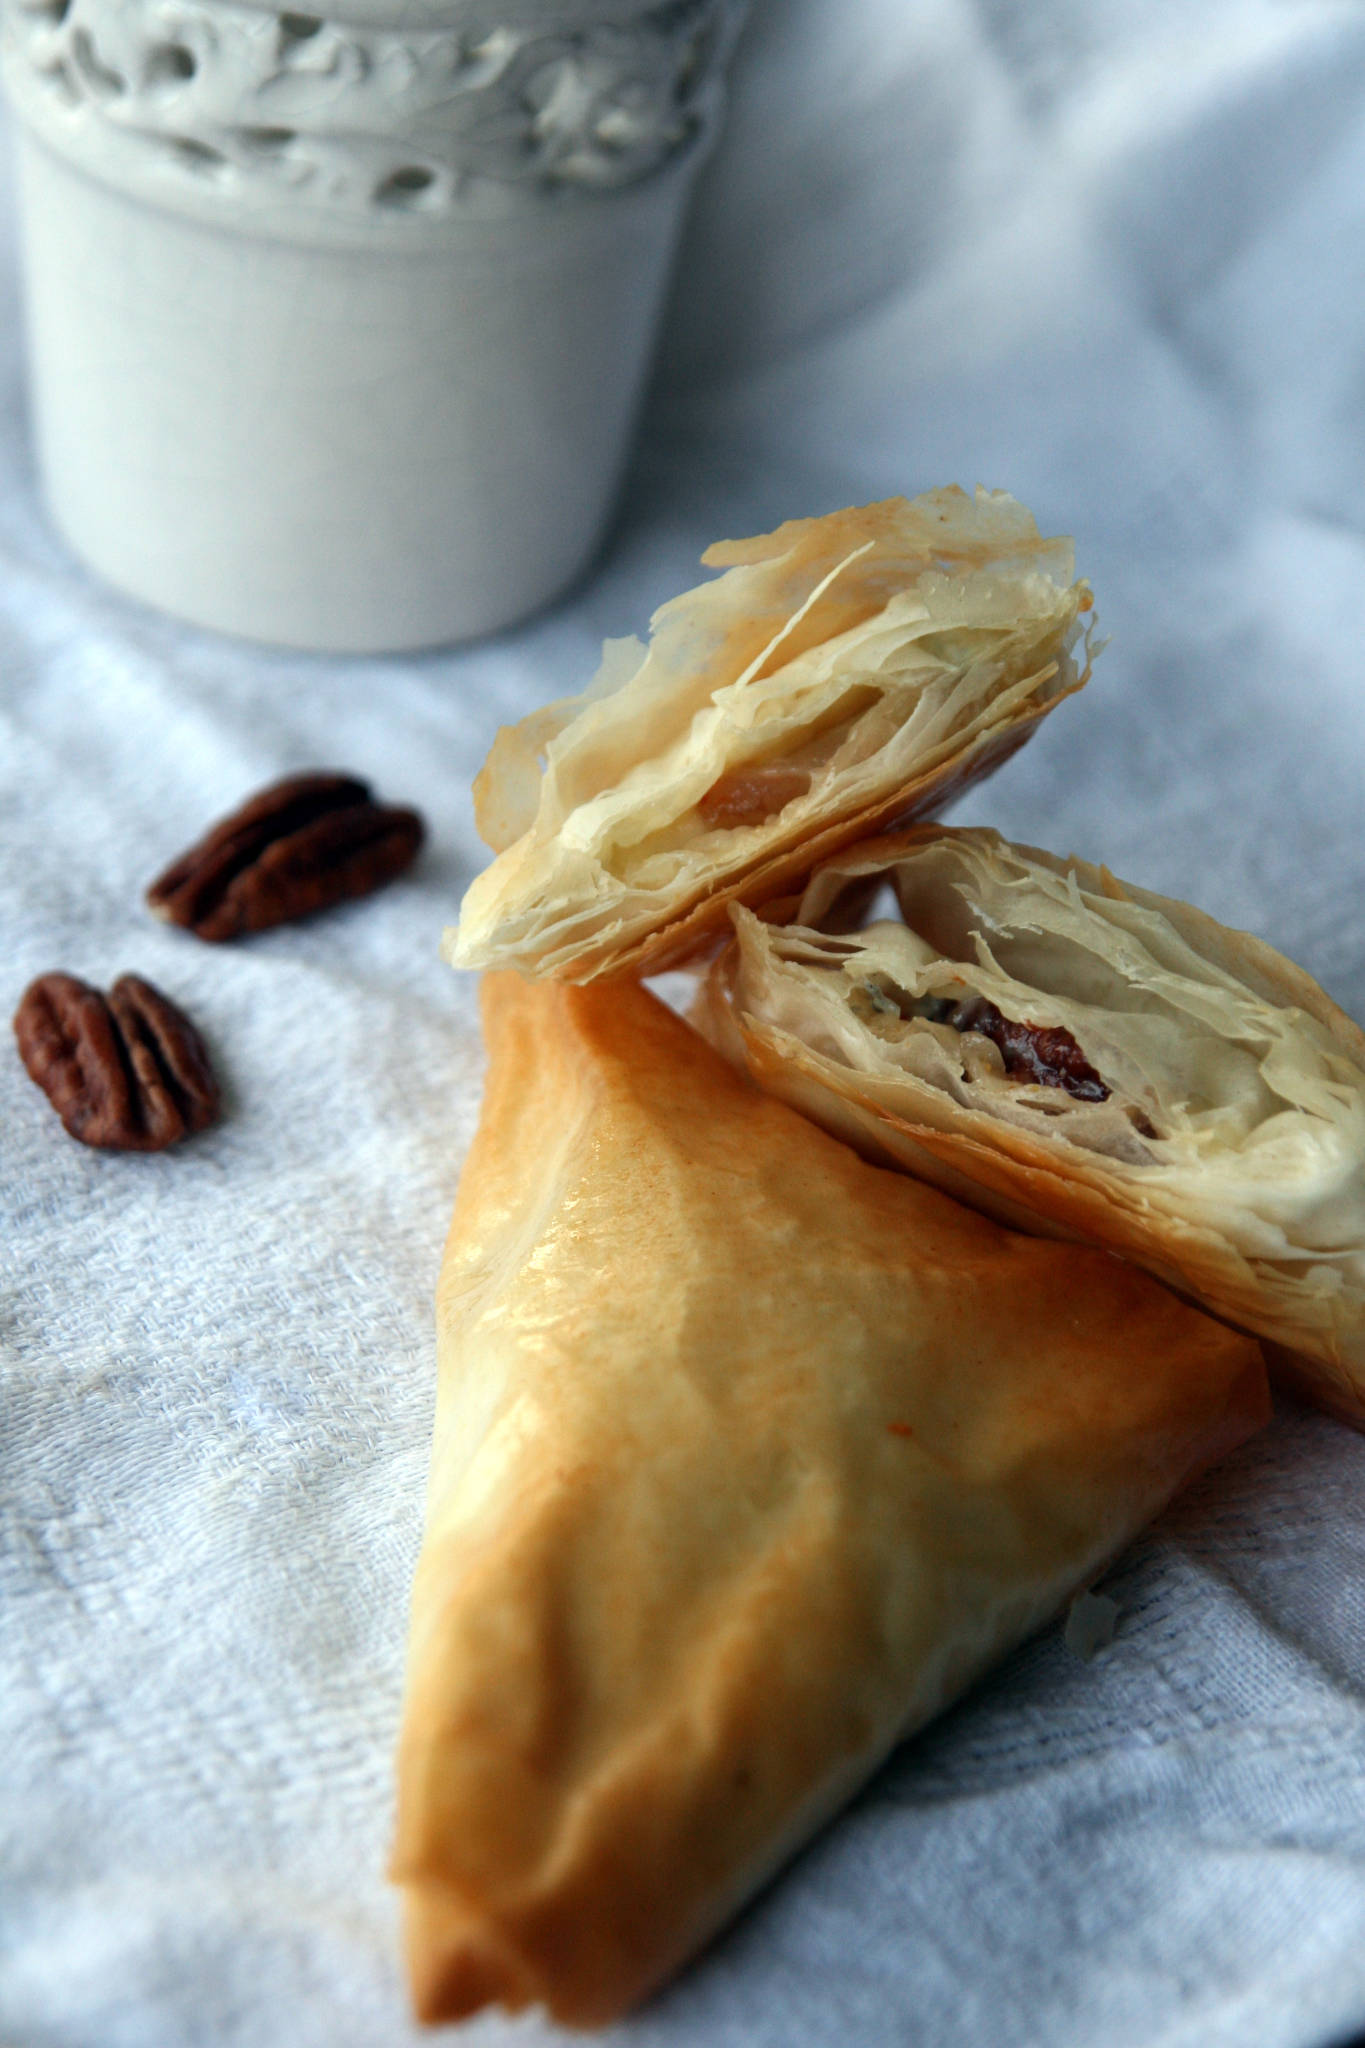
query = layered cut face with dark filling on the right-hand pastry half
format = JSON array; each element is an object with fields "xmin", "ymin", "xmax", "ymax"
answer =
[{"xmin": 712, "ymin": 829, "xmax": 1365, "ymax": 1187}]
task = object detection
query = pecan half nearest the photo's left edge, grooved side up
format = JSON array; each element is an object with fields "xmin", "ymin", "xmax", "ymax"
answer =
[{"xmin": 14, "ymin": 975, "xmax": 219, "ymax": 1151}]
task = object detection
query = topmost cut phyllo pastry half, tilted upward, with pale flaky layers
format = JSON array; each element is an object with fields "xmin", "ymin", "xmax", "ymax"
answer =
[{"xmin": 446, "ymin": 489, "xmax": 1091, "ymax": 981}]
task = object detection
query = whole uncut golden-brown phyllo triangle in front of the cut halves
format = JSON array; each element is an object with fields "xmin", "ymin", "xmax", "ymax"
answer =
[{"xmin": 393, "ymin": 975, "xmax": 1267, "ymax": 2023}]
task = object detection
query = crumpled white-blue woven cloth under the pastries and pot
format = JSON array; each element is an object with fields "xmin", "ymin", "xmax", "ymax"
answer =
[{"xmin": 0, "ymin": 0, "xmax": 1365, "ymax": 2048}]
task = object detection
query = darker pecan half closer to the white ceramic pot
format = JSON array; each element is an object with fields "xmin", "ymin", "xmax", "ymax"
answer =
[{"xmin": 147, "ymin": 774, "xmax": 426, "ymax": 940}]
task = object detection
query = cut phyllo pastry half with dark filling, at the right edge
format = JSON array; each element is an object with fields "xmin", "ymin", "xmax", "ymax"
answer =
[{"xmin": 698, "ymin": 827, "xmax": 1365, "ymax": 1425}]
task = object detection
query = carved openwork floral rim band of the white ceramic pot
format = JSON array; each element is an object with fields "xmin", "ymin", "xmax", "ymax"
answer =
[{"xmin": 4, "ymin": 0, "xmax": 741, "ymax": 238}]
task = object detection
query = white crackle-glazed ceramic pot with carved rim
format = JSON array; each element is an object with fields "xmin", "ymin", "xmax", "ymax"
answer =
[{"xmin": 4, "ymin": 0, "xmax": 741, "ymax": 651}]
